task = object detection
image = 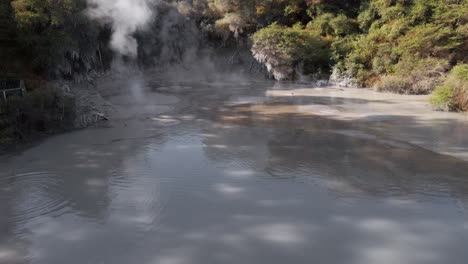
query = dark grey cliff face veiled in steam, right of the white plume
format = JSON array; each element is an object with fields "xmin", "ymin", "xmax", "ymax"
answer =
[{"xmin": 136, "ymin": 2, "xmax": 264, "ymax": 73}]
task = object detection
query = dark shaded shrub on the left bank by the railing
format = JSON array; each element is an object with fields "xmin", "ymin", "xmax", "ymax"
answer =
[{"xmin": 0, "ymin": 88, "xmax": 75, "ymax": 145}]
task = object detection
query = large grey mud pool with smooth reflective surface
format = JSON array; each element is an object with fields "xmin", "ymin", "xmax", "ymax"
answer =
[{"xmin": 0, "ymin": 78, "xmax": 468, "ymax": 264}]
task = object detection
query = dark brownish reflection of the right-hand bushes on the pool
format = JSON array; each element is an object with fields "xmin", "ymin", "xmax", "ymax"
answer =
[{"xmin": 205, "ymin": 101, "xmax": 468, "ymax": 201}]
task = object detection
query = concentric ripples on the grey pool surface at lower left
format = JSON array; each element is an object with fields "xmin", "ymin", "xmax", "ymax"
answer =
[{"xmin": 0, "ymin": 172, "xmax": 68, "ymax": 222}]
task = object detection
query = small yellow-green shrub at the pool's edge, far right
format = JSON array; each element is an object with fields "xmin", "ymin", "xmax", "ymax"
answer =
[{"xmin": 430, "ymin": 64, "xmax": 468, "ymax": 111}]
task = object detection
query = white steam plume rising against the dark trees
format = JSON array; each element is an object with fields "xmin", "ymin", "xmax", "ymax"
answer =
[{"xmin": 87, "ymin": 0, "xmax": 158, "ymax": 57}]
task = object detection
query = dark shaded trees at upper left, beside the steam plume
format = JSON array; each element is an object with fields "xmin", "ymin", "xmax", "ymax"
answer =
[{"xmin": 11, "ymin": 0, "xmax": 106, "ymax": 77}]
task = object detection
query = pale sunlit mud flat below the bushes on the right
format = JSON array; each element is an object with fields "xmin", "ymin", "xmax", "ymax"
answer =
[{"xmin": 263, "ymin": 86, "xmax": 468, "ymax": 160}]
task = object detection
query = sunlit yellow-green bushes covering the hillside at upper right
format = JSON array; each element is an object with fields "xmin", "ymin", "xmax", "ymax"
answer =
[{"xmin": 197, "ymin": 0, "xmax": 468, "ymax": 106}]
